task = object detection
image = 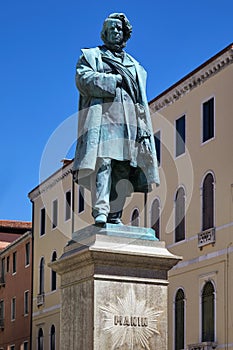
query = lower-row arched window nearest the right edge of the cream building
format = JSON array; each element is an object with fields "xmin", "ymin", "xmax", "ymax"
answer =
[{"xmin": 201, "ymin": 281, "xmax": 215, "ymax": 342}]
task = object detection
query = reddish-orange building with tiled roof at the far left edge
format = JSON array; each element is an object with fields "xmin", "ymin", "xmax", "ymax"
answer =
[{"xmin": 0, "ymin": 221, "xmax": 32, "ymax": 350}]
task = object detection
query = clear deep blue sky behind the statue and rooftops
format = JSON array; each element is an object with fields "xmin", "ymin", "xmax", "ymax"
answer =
[{"xmin": 0, "ymin": 0, "xmax": 233, "ymax": 220}]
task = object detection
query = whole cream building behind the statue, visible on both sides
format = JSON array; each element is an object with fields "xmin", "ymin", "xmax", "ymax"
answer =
[{"xmin": 29, "ymin": 45, "xmax": 233, "ymax": 350}]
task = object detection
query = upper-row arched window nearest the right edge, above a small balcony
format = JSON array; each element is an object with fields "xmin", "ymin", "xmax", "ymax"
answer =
[{"xmin": 202, "ymin": 173, "xmax": 214, "ymax": 231}]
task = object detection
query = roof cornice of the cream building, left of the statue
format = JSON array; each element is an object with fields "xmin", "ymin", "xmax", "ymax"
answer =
[{"xmin": 28, "ymin": 162, "xmax": 73, "ymax": 201}]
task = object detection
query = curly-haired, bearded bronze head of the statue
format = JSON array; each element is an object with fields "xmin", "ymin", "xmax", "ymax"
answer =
[{"xmin": 101, "ymin": 13, "xmax": 132, "ymax": 51}]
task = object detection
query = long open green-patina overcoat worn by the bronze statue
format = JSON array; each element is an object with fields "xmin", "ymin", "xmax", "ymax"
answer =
[{"xmin": 73, "ymin": 47, "xmax": 159, "ymax": 192}]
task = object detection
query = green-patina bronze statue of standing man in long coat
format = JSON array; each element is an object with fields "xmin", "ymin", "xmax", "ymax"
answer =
[{"xmin": 73, "ymin": 13, "xmax": 159, "ymax": 224}]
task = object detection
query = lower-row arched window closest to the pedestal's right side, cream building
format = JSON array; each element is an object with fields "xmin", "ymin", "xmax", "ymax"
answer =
[{"xmin": 175, "ymin": 289, "xmax": 185, "ymax": 350}]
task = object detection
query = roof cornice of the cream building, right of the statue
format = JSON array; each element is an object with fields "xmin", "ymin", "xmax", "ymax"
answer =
[{"xmin": 150, "ymin": 45, "xmax": 233, "ymax": 112}]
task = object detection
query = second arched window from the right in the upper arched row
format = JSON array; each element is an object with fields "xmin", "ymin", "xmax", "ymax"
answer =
[{"xmin": 175, "ymin": 187, "xmax": 185, "ymax": 242}]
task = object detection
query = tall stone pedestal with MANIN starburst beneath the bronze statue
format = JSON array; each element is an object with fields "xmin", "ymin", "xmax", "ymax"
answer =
[{"xmin": 50, "ymin": 224, "xmax": 181, "ymax": 350}]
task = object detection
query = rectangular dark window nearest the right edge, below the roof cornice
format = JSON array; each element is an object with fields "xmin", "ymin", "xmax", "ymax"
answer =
[{"xmin": 202, "ymin": 97, "xmax": 214, "ymax": 142}]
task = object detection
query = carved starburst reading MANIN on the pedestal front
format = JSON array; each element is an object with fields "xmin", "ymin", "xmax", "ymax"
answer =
[{"xmin": 100, "ymin": 288, "xmax": 162, "ymax": 350}]
